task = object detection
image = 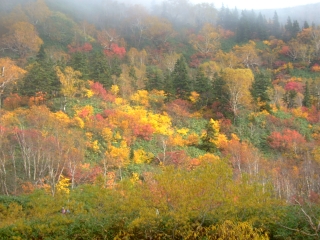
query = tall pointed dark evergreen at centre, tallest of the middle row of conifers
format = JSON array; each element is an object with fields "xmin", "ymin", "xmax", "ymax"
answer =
[{"xmin": 172, "ymin": 57, "xmax": 192, "ymax": 99}]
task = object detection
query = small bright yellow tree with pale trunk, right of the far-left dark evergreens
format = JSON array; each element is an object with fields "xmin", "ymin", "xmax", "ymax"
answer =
[{"xmin": 56, "ymin": 67, "xmax": 84, "ymax": 111}]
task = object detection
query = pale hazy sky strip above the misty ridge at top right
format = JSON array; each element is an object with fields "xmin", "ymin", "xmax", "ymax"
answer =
[{"xmin": 191, "ymin": 0, "xmax": 320, "ymax": 10}]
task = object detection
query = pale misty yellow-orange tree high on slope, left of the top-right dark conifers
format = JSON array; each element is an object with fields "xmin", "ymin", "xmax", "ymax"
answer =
[{"xmin": 190, "ymin": 23, "xmax": 220, "ymax": 55}]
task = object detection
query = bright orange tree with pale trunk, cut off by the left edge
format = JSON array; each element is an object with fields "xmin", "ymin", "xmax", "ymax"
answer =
[{"xmin": 0, "ymin": 58, "xmax": 26, "ymax": 108}]
